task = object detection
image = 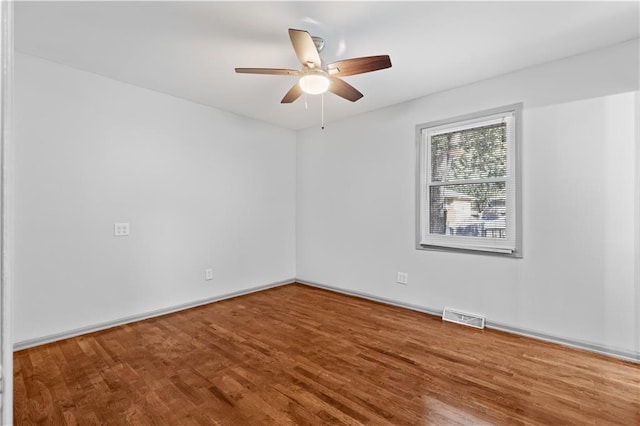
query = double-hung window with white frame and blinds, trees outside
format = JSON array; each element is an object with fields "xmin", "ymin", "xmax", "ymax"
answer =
[{"xmin": 416, "ymin": 104, "xmax": 522, "ymax": 257}]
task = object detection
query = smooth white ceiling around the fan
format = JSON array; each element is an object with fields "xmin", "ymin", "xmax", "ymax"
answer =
[{"xmin": 15, "ymin": 1, "xmax": 640, "ymax": 129}]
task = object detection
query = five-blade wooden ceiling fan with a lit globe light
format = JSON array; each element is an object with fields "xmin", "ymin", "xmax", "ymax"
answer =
[{"xmin": 236, "ymin": 29, "xmax": 391, "ymax": 104}]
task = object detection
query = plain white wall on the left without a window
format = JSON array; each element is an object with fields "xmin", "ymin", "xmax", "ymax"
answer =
[{"xmin": 12, "ymin": 54, "xmax": 296, "ymax": 342}]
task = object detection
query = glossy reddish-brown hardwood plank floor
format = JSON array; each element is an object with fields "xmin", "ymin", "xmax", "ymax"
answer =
[{"xmin": 14, "ymin": 284, "xmax": 640, "ymax": 426}]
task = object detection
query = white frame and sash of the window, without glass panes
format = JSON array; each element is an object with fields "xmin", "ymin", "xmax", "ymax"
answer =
[{"xmin": 416, "ymin": 103, "xmax": 522, "ymax": 257}]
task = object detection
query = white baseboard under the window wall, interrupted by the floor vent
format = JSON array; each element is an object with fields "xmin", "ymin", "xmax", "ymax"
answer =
[{"xmin": 296, "ymin": 278, "xmax": 640, "ymax": 363}]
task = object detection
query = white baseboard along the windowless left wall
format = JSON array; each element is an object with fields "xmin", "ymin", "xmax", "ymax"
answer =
[{"xmin": 13, "ymin": 278, "xmax": 295, "ymax": 351}]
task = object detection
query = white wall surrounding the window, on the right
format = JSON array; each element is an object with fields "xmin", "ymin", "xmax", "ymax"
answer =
[{"xmin": 296, "ymin": 40, "xmax": 640, "ymax": 353}]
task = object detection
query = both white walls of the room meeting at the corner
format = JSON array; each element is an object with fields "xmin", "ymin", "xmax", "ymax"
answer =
[{"xmin": 12, "ymin": 40, "xmax": 640, "ymax": 360}]
